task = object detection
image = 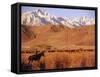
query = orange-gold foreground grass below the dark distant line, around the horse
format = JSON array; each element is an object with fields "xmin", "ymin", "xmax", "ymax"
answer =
[{"xmin": 22, "ymin": 46, "xmax": 95, "ymax": 70}]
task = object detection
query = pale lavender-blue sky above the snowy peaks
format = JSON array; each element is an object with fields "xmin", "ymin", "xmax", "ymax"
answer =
[{"xmin": 21, "ymin": 6, "xmax": 95, "ymax": 18}]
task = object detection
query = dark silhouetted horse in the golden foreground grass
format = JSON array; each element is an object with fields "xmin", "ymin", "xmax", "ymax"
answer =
[{"xmin": 28, "ymin": 51, "xmax": 44, "ymax": 64}]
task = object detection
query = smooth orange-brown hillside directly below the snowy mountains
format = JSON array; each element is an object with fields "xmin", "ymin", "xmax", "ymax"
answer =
[{"xmin": 22, "ymin": 24, "xmax": 95, "ymax": 48}]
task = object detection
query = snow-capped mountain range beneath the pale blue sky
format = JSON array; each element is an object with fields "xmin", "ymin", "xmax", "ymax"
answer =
[{"xmin": 21, "ymin": 9, "xmax": 95, "ymax": 28}]
